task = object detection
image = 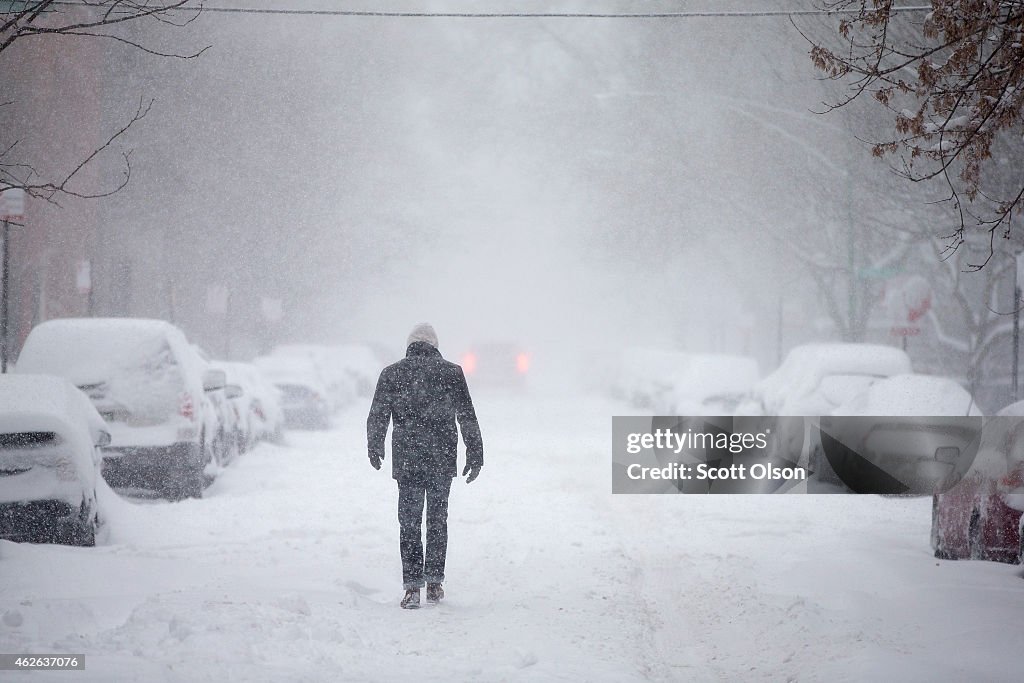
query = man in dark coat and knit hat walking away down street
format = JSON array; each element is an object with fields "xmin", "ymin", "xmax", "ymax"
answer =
[{"xmin": 367, "ymin": 323, "xmax": 483, "ymax": 609}]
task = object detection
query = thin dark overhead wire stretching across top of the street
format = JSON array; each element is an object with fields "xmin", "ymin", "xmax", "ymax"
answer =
[{"xmin": 54, "ymin": 0, "xmax": 932, "ymax": 19}]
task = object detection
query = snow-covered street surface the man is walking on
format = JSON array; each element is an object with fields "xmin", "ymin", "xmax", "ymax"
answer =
[{"xmin": 0, "ymin": 394, "xmax": 1024, "ymax": 681}]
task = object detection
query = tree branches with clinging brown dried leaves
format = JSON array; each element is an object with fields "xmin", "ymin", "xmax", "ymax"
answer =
[{"xmin": 798, "ymin": 0, "xmax": 1024, "ymax": 269}]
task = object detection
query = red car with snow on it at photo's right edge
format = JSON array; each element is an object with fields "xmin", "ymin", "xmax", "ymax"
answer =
[{"xmin": 932, "ymin": 401, "xmax": 1024, "ymax": 564}]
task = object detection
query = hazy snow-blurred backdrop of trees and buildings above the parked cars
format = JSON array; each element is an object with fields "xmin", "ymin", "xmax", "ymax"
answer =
[{"xmin": 0, "ymin": 0, "xmax": 1020, "ymax": 407}]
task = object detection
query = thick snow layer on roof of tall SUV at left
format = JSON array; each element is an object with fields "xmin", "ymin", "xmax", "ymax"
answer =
[{"xmin": 17, "ymin": 317, "xmax": 176, "ymax": 384}]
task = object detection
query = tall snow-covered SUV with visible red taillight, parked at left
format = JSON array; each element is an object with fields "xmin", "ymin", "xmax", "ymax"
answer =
[{"xmin": 18, "ymin": 318, "xmax": 224, "ymax": 500}]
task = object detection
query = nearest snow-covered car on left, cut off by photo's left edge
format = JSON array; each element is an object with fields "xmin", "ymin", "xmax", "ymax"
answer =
[{"xmin": 0, "ymin": 374, "xmax": 111, "ymax": 546}]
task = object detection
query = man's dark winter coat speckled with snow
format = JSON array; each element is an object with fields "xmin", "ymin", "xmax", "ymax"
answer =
[{"xmin": 367, "ymin": 342, "xmax": 483, "ymax": 481}]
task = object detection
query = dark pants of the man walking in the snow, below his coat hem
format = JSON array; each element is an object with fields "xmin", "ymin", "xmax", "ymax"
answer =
[{"xmin": 398, "ymin": 478, "xmax": 452, "ymax": 590}]
